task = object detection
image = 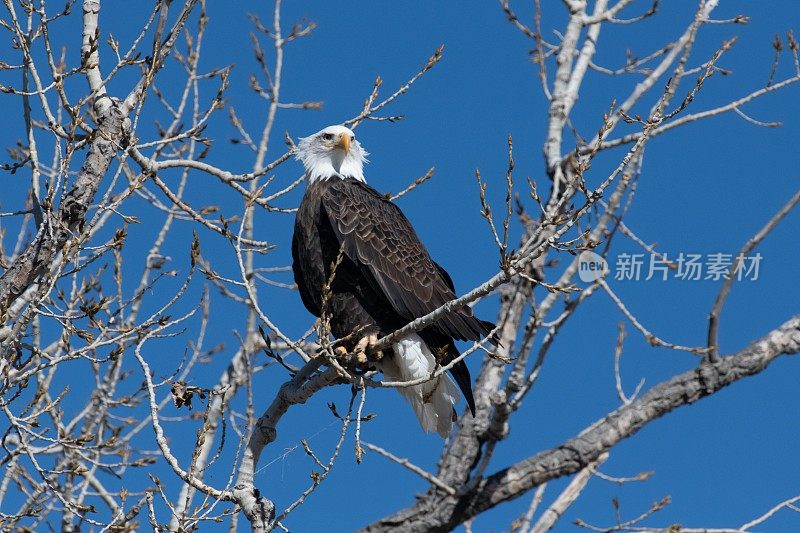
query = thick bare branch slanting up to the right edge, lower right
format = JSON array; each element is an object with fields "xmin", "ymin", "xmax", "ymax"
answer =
[{"xmin": 363, "ymin": 316, "xmax": 800, "ymax": 533}]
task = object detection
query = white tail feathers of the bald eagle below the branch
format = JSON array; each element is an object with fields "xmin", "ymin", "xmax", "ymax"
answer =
[{"xmin": 377, "ymin": 333, "xmax": 458, "ymax": 438}]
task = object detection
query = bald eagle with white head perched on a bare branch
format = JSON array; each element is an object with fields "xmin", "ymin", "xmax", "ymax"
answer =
[{"xmin": 292, "ymin": 126, "xmax": 494, "ymax": 438}]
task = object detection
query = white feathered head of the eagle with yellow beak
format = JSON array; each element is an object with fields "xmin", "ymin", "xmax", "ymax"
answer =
[{"xmin": 297, "ymin": 126, "xmax": 369, "ymax": 182}]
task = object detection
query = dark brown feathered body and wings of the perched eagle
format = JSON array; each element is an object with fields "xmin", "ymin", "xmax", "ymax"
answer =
[{"xmin": 292, "ymin": 176, "xmax": 494, "ymax": 413}]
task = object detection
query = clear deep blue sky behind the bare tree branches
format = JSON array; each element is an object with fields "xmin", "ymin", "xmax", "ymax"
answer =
[{"xmin": 3, "ymin": 0, "xmax": 800, "ymax": 531}]
